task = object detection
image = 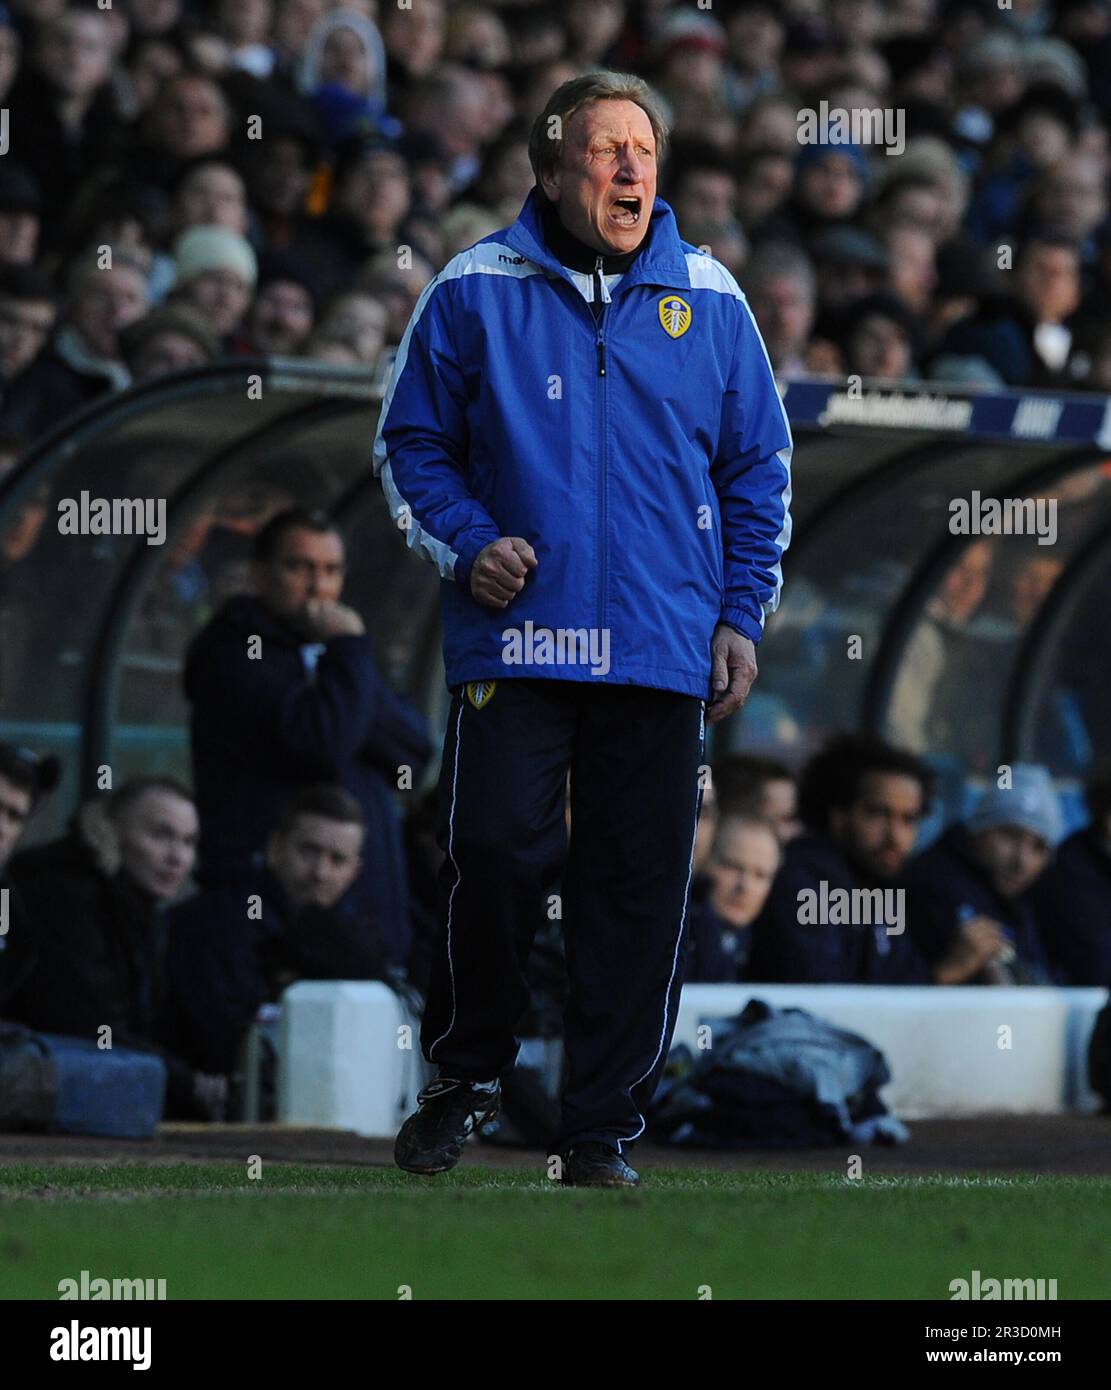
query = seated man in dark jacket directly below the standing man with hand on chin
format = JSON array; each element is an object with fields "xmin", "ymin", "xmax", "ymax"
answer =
[{"xmin": 160, "ymin": 785, "xmax": 388, "ymax": 1074}]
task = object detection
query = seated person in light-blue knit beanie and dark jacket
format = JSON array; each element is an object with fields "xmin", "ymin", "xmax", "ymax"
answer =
[{"xmin": 905, "ymin": 763, "xmax": 1061, "ymax": 984}]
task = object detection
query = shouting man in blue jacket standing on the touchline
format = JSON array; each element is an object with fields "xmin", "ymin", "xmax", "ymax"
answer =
[{"xmin": 374, "ymin": 72, "xmax": 791, "ymax": 1186}]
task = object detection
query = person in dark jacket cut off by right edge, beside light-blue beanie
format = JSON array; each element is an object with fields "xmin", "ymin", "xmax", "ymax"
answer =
[{"xmin": 1030, "ymin": 767, "xmax": 1111, "ymax": 988}]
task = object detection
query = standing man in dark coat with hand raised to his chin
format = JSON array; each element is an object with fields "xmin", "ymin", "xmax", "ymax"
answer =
[{"xmin": 185, "ymin": 510, "xmax": 430, "ymax": 963}]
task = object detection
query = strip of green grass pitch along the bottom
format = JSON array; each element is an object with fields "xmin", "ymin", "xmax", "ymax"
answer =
[{"xmin": 0, "ymin": 1162, "xmax": 1111, "ymax": 1300}]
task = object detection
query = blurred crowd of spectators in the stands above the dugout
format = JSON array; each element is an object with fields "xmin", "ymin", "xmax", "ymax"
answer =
[{"xmin": 0, "ymin": 0, "xmax": 1111, "ymax": 443}]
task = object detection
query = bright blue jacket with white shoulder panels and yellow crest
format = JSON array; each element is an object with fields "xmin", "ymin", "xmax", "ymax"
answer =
[{"xmin": 374, "ymin": 189, "xmax": 791, "ymax": 698}]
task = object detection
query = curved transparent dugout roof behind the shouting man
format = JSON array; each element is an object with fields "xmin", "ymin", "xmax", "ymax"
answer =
[{"xmin": 0, "ymin": 359, "xmax": 1111, "ymax": 838}]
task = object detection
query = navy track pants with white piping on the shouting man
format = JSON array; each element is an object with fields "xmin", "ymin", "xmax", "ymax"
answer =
[{"xmin": 421, "ymin": 678, "xmax": 705, "ymax": 1151}]
